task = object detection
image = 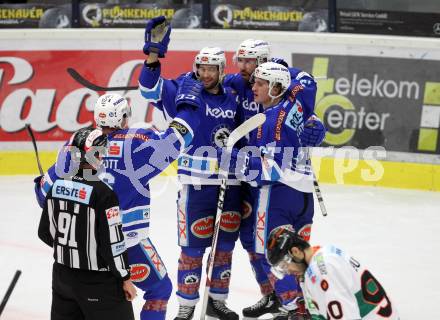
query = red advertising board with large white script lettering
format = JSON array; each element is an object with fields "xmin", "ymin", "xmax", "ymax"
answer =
[{"xmin": 0, "ymin": 50, "xmax": 237, "ymax": 141}]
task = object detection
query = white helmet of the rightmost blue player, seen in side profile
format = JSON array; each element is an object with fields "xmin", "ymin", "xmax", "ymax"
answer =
[{"xmin": 254, "ymin": 62, "xmax": 291, "ymax": 99}]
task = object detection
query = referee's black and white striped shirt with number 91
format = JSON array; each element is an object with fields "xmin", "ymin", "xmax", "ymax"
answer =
[{"xmin": 38, "ymin": 170, "xmax": 130, "ymax": 280}]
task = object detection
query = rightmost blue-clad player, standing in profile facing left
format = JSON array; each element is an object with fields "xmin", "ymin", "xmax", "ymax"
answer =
[{"xmin": 237, "ymin": 62, "xmax": 324, "ymax": 320}]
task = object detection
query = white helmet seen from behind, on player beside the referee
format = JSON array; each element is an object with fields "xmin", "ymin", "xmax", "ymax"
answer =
[{"xmin": 94, "ymin": 93, "xmax": 131, "ymax": 129}]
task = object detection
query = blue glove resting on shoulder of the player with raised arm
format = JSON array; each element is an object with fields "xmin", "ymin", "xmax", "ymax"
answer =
[{"xmin": 175, "ymin": 73, "xmax": 203, "ymax": 109}]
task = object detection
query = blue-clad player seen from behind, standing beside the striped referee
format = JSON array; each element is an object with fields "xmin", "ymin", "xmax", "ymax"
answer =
[{"xmin": 36, "ymin": 88, "xmax": 202, "ymax": 320}]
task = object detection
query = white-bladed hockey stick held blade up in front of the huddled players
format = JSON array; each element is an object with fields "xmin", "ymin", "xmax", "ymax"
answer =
[{"xmin": 200, "ymin": 113, "xmax": 266, "ymax": 320}]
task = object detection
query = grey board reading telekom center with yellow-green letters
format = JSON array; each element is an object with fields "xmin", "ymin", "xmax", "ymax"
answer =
[{"xmin": 292, "ymin": 54, "xmax": 440, "ymax": 154}]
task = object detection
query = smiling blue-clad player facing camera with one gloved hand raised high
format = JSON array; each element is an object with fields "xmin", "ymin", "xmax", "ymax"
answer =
[{"xmin": 139, "ymin": 17, "xmax": 241, "ymax": 320}]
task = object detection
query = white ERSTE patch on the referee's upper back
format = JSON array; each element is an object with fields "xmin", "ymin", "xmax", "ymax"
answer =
[{"xmin": 52, "ymin": 180, "xmax": 93, "ymax": 204}]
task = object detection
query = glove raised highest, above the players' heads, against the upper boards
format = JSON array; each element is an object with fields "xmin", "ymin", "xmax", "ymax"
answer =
[{"xmin": 144, "ymin": 16, "xmax": 171, "ymax": 58}]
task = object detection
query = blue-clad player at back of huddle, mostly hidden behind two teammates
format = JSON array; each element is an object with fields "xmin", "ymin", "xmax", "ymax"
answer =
[{"xmin": 224, "ymin": 39, "xmax": 325, "ymax": 319}]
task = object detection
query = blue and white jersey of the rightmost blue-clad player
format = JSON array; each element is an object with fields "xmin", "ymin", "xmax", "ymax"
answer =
[{"xmin": 249, "ymin": 80, "xmax": 315, "ymax": 192}]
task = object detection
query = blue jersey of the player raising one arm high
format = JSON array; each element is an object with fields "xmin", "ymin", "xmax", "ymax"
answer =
[{"xmin": 139, "ymin": 65, "xmax": 240, "ymax": 185}]
